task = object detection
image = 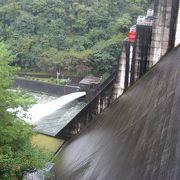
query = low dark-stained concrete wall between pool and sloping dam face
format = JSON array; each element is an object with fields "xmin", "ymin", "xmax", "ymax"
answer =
[{"xmin": 56, "ymin": 74, "xmax": 115, "ymax": 140}]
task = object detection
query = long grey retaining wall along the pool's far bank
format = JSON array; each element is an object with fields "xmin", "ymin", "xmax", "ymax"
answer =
[{"xmin": 13, "ymin": 78, "xmax": 79, "ymax": 96}]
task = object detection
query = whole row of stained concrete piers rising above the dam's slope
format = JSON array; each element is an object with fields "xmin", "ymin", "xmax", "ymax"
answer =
[{"xmin": 113, "ymin": 0, "xmax": 180, "ymax": 100}]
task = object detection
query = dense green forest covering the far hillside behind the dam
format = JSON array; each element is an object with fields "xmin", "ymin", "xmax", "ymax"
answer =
[{"xmin": 0, "ymin": 0, "xmax": 148, "ymax": 75}]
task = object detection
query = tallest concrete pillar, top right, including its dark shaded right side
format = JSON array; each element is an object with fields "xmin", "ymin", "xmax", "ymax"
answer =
[{"xmin": 150, "ymin": 0, "xmax": 179, "ymax": 65}]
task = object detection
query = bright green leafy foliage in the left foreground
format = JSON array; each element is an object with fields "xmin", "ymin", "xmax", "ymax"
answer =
[{"xmin": 0, "ymin": 43, "xmax": 48, "ymax": 180}]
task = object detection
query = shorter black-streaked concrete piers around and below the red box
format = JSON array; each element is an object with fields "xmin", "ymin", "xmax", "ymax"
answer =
[{"xmin": 113, "ymin": 25, "xmax": 152, "ymax": 100}]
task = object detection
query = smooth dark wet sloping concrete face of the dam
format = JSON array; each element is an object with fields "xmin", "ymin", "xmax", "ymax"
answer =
[{"xmin": 51, "ymin": 47, "xmax": 180, "ymax": 180}]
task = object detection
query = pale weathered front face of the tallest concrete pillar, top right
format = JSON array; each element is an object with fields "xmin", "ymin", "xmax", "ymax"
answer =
[{"xmin": 150, "ymin": 0, "xmax": 173, "ymax": 65}]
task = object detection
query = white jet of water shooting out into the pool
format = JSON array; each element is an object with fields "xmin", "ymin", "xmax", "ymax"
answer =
[{"xmin": 28, "ymin": 92, "xmax": 86, "ymax": 124}]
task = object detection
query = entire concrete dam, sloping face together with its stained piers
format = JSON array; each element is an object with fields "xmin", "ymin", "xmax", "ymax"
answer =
[{"xmin": 49, "ymin": 0, "xmax": 180, "ymax": 180}]
